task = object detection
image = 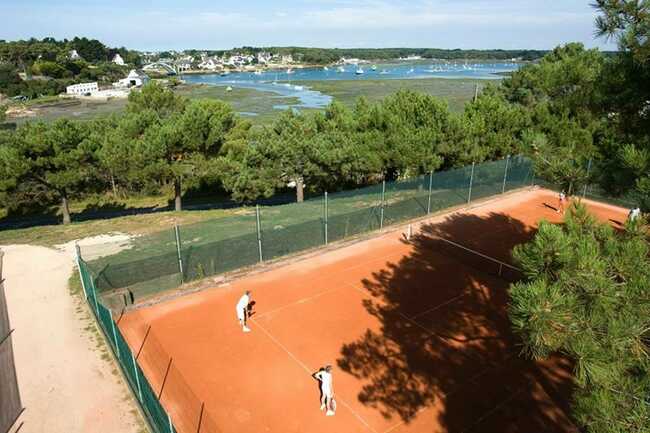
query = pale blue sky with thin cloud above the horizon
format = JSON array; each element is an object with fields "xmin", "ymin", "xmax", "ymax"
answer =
[{"xmin": 0, "ymin": 0, "xmax": 615, "ymax": 50}]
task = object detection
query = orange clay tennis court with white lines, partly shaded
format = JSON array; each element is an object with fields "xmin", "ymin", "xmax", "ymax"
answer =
[{"xmin": 119, "ymin": 190, "xmax": 626, "ymax": 433}]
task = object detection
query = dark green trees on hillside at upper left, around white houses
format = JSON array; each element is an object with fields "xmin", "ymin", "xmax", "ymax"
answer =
[{"xmin": 0, "ymin": 38, "xmax": 142, "ymax": 99}]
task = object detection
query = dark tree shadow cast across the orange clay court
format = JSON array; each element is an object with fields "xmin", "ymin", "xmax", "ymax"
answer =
[{"xmin": 338, "ymin": 213, "xmax": 576, "ymax": 432}]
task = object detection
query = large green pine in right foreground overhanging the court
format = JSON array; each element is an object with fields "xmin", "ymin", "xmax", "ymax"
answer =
[{"xmin": 510, "ymin": 203, "xmax": 650, "ymax": 433}]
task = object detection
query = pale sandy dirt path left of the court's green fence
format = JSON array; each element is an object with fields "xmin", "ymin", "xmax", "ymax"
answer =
[{"xmin": 2, "ymin": 245, "xmax": 142, "ymax": 433}]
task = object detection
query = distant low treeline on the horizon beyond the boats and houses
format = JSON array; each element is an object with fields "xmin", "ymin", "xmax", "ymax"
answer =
[{"xmin": 190, "ymin": 47, "xmax": 547, "ymax": 65}]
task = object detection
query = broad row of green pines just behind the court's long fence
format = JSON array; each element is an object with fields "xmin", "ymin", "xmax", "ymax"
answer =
[{"xmin": 0, "ymin": 40, "xmax": 650, "ymax": 224}]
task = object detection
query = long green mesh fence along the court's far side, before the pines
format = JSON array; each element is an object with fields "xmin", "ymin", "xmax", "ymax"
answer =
[{"xmin": 84, "ymin": 157, "xmax": 533, "ymax": 307}]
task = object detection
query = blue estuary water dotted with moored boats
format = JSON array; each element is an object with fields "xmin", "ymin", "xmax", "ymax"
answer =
[{"xmin": 183, "ymin": 61, "xmax": 521, "ymax": 110}]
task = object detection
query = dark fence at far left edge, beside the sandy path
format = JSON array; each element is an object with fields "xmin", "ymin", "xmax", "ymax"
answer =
[{"xmin": 0, "ymin": 251, "xmax": 23, "ymax": 433}]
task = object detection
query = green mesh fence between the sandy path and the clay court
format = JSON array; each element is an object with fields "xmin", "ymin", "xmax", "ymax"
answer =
[{"xmin": 77, "ymin": 251, "xmax": 220, "ymax": 433}]
